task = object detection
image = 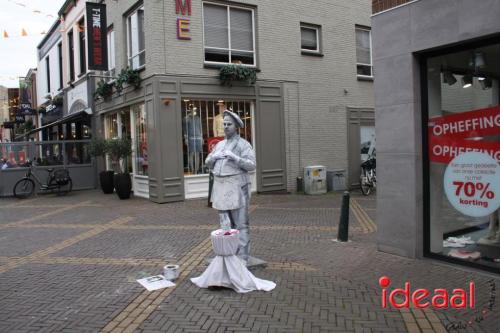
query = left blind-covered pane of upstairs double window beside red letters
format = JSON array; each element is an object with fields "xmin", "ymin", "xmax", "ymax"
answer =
[{"xmin": 203, "ymin": 4, "xmax": 229, "ymax": 49}]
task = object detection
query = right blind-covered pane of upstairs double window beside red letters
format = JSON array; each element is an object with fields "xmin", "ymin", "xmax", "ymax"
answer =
[{"xmin": 230, "ymin": 8, "xmax": 253, "ymax": 51}]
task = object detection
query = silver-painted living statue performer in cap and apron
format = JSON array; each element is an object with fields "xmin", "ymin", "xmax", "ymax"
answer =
[{"xmin": 205, "ymin": 110, "xmax": 255, "ymax": 263}]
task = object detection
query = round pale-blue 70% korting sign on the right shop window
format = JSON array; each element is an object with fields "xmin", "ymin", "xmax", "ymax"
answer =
[{"xmin": 443, "ymin": 152, "xmax": 500, "ymax": 217}]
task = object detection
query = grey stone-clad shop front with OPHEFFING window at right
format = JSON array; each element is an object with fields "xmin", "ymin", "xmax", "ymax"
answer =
[{"xmin": 372, "ymin": 1, "xmax": 500, "ymax": 273}]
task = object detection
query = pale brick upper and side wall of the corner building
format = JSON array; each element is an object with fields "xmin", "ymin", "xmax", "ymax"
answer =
[{"xmin": 106, "ymin": 0, "xmax": 374, "ymax": 190}]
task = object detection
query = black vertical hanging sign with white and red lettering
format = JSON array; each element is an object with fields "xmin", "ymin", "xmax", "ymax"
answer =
[{"xmin": 86, "ymin": 2, "xmax": 108, "ymax": 71}]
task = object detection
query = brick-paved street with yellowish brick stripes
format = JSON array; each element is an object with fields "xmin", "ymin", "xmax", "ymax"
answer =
[{"xmin": 0, "ymin": 191, "xmax": 500, "ymax": 332}]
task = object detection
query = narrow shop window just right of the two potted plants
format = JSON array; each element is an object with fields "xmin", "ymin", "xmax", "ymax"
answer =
[{"xmin": 132, "ymin": 104, "xmax": 148, "ymax": 176}]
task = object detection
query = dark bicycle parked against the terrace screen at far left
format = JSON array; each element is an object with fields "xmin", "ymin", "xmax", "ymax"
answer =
[{"xmin": 13, "ymin": 162, "xmax": 73, "ymax": 199}]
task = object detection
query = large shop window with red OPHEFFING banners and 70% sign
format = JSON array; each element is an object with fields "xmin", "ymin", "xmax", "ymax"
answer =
[{"xmin": 427, "ymin": 44, "xmax": 500, "ymax": 271}]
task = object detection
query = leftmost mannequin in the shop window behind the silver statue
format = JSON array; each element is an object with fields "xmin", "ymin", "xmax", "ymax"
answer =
[{"xmin": 184, "ymin": 108, "xmax": 203, "ymax": 174}]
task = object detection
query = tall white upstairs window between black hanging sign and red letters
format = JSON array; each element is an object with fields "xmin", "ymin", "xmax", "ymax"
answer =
[{"xmin": 127, "ymin": 7, "xmax": 146, "ymax": 69}]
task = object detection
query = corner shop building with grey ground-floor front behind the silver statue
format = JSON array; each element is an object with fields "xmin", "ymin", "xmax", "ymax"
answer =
[{"xmin": 96, "ymin": 0, "xmax": 374, "ymax": 202}]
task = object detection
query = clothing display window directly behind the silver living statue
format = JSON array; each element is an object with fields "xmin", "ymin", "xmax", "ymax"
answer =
[{"xmin": 182, "ymin": 98, "xmax": 253, "ymax": 176}]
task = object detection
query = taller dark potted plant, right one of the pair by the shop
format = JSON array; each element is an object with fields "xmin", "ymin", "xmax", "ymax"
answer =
[{"xmin": 108, "ymin": 138, "xmax": 132, "ymax": 200}]
